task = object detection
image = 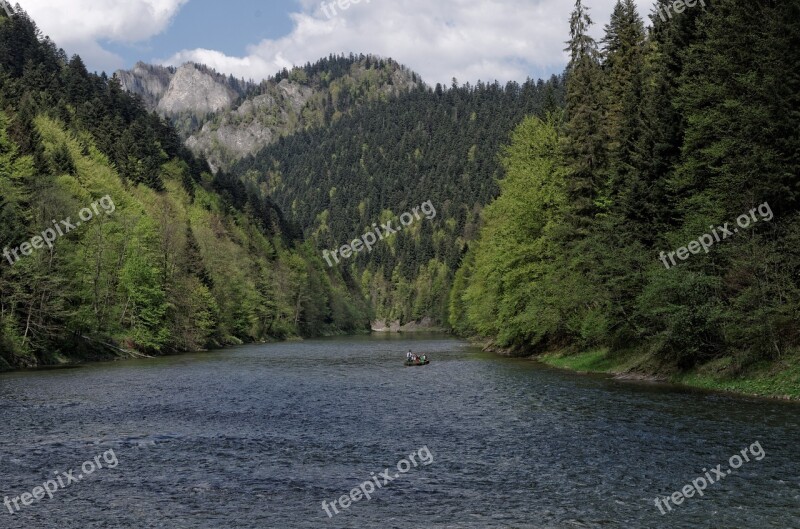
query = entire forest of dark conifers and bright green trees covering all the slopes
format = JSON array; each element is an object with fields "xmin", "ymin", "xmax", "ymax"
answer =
[{"xmin": 0, "ymin": 0, "xmax": 800, "ymax": 380}]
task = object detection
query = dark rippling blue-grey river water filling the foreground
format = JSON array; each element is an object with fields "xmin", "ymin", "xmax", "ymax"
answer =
[{"xmin": 0, "ymin": 336, "xmax": 800, "ymax": 529}]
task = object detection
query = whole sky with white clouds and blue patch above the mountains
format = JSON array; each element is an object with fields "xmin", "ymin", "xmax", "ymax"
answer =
[{"xmin": 17, "ymin": 0, "xmax": 653, "ymax": 85}]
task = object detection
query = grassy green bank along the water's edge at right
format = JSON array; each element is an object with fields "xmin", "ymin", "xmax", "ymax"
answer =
[{"xmin": 537, "ymin": 349, "xmax": 800, "ymax": 400}]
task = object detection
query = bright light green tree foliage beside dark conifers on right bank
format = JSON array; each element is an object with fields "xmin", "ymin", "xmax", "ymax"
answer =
[{"xmin": 450, "ymin": 116, "xmax": 567, "ymax": 346}]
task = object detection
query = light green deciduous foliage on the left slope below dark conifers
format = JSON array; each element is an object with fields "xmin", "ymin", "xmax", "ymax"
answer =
[{"xmin": 0, "ymin": 109, "xmax": 368, "ymax": 366}]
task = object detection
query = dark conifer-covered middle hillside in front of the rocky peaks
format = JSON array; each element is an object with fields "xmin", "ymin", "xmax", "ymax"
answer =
[{"xmin": 231, "ymin": 76, "xmax": 564, "ymax": 324}]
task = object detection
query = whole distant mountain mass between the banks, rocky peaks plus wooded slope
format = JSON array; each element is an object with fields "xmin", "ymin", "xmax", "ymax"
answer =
[{"xmin": 117, "ymin": 55, "xmax": 564, "ymax": 327}]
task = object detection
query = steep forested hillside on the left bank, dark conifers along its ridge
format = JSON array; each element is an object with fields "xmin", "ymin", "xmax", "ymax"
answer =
[{"xmin": 0, "ymin": 9, "xmax": 369, "ymax": 369}]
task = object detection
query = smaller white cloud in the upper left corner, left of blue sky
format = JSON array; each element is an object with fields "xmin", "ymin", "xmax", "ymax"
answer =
[{"xmin": 19, "ymin": 0, "xmax": 189, "ymax": 72}]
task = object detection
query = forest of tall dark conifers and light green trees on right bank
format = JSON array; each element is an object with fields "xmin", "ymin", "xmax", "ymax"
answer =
[{"xmin": 450, "ymin": 0, "xmax": 800, "ymax": 372}]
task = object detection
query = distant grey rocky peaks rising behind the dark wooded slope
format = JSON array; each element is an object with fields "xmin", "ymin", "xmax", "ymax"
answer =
[{"xmin": 115, "ymin": 55, "xmax": 421, "ymax": 171}]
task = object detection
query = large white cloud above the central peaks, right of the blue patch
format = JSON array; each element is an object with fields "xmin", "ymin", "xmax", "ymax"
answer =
[{"xmin": 160, "ymin": 0, "xmax": 653, "ymax": 84}]
